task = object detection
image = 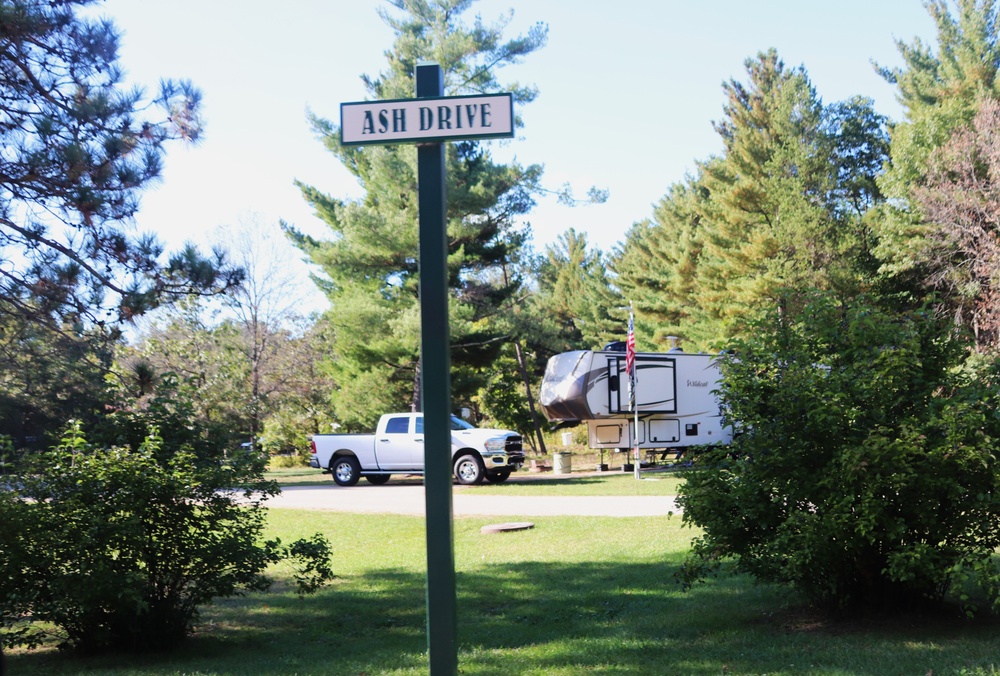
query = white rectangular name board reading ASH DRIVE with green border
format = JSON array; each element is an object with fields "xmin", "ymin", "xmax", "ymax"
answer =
[{"xmin": 340, "ymin": 94, "xmax": 514, "ymax": 146}]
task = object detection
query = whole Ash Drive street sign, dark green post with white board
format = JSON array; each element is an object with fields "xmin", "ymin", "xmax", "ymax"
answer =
[{"xmin": 340, "ymin": 63, "xmax": 514, "ymax": 676}]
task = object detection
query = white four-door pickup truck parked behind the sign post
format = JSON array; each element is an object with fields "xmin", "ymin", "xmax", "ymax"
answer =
[{"xmin": 309, "ymin": 413, "xmax": 524, "ymax": 486}]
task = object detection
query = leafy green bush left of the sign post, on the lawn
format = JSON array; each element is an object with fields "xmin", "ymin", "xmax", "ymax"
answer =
[{"xmin": 0, "ymin": 424, "xmax": 332, "ymax": 652}]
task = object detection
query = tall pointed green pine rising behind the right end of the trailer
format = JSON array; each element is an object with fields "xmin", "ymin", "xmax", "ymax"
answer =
[{"xmin": 699, "ymin": 50, "xmax": 840, "ymax": 336}]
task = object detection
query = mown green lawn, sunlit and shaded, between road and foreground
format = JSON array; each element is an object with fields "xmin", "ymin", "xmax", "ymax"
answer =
[{"xmin": 8, "ymin": 510, "xmax": 1000, "ymax": 676}]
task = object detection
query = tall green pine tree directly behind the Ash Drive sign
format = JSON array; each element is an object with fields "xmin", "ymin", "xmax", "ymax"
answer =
[{"xmin": 286, "ymin": 0, "xmax": 547, "ymax": 428}]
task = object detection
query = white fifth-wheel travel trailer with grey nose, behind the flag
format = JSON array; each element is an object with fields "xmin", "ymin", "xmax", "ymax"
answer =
[{"xmin": 539, "ymin": 344, "xmax": 732, "ymax": 457}]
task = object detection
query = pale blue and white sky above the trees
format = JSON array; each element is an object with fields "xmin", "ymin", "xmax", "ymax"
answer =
[{"xmin": 98, "ymin": 0, "xmax": 935, "ymax": 307}]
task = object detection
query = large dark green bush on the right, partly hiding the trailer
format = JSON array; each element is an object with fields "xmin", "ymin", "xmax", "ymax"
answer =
[{"xmin": 680, "ymin": 296, "xmax": 1000, "ymax": 610}]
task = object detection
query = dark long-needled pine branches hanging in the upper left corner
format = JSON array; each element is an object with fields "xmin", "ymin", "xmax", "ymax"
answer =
[{"xmin": 0, "ymin": 0, "xmax": 240, "ymax": 330}]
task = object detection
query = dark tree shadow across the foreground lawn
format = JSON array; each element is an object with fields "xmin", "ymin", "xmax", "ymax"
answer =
[{"xmin": 8, "ymin": 562, "xmax": 1000, "ymax": 675}]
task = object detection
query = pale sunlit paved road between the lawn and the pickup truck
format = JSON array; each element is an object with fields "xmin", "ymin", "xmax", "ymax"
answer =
[{"xmin": 267, "ymin": 482, "xmax": 679, "ymax": 517}]
